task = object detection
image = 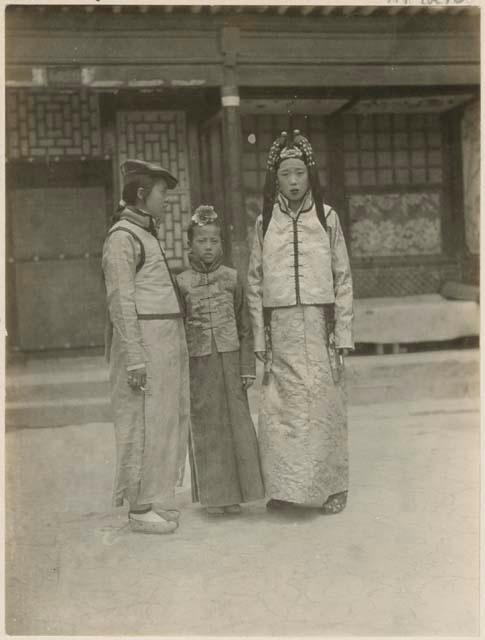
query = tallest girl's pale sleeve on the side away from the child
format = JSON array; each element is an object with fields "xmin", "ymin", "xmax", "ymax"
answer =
[{"xmin": 327, "ymin": 210, "xmax": 354, "ymax": 349}]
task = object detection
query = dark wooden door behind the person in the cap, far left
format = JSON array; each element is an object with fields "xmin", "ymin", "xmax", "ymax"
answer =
[{"xmin": 7, "ymin": 162, "xmax": 111, "ymax": 351}]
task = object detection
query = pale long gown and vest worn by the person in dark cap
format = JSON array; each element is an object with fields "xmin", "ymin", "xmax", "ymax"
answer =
[{"xmin": 103, "ymin": 209, "xmax": 190, "ymax": 506}]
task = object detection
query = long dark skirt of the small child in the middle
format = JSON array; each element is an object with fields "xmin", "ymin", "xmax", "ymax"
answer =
[{"xmin": 190, "ymin": 348, "xmax": 264, "ymax": 507}]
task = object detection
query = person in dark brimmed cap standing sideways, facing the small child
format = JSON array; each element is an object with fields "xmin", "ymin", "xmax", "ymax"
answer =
[{"xmin": 102, "ymin": 160, "xmax": 190, "ymax": 533}]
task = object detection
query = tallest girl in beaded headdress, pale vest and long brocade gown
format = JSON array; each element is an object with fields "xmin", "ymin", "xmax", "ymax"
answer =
[{"xmin": 248, "ymin": 131, "xmax": 353, "ymax": 514}]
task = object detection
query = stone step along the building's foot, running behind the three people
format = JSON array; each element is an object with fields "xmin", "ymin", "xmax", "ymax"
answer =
[{"xmin": 6, "ymin": 349, "xmax": 479, "ymax": 428}]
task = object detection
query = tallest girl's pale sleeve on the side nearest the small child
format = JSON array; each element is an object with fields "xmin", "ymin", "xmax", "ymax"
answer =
[{"xmin": 247, "ymin": 217, "xmax": 266, "ymax": 351}]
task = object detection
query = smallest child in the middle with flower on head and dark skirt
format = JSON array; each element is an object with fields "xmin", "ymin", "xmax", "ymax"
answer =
[{"xmin": 177, "ymin": 205, "xmax": 264, "ymax": 515}]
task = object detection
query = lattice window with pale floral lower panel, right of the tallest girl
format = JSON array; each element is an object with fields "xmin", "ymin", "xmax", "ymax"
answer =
[{"xmin": 343, "ymin": 114, "xmax": 447, "ymax": 258}]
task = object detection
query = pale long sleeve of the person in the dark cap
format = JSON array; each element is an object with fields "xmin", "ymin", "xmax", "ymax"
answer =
[{"xmin": 102, "ymin": 231, "xmax": 146, "ymax": 368}]
